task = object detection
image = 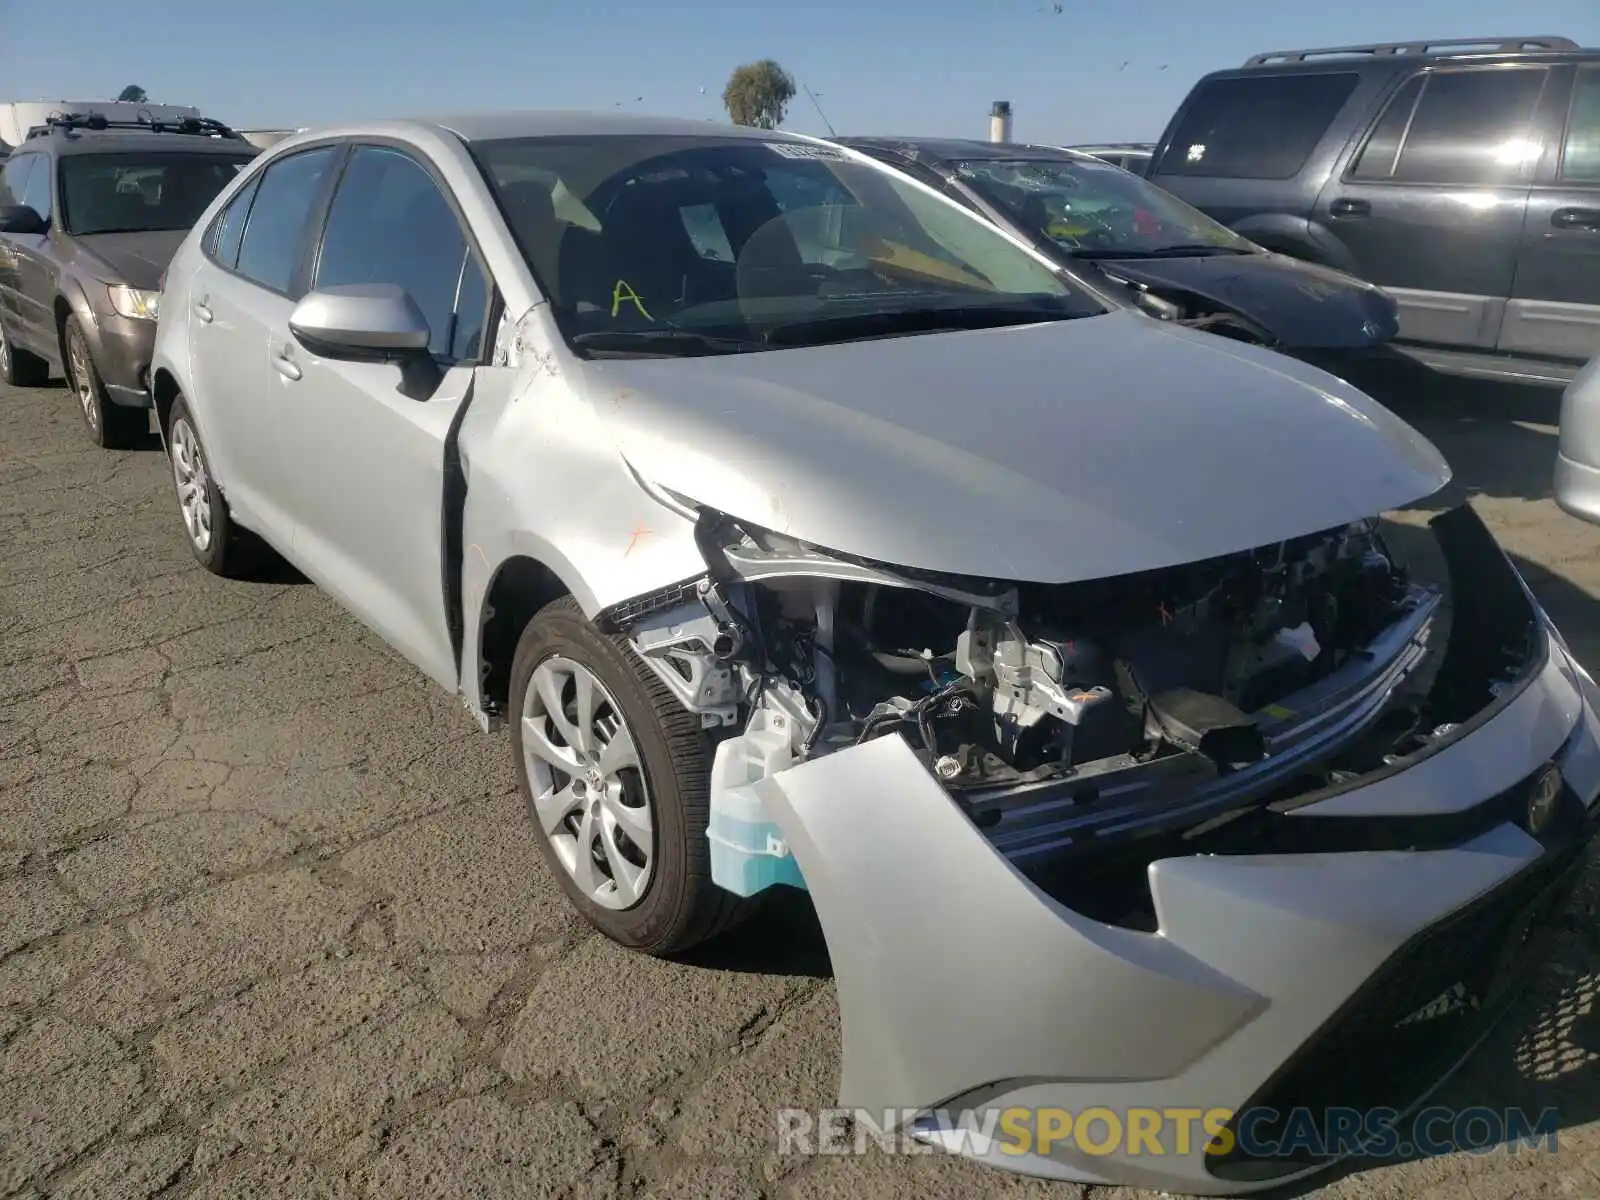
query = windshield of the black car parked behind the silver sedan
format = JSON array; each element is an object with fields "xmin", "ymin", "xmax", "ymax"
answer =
[{"xmin": 957, "ymin": 158, "xmax": 1254, "ymax": 256}]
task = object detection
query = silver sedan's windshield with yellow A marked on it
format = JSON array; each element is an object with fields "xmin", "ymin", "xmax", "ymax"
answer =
[{"xmin": 474, "ymin": 136, "xmax": 1102, "ymax": 355}]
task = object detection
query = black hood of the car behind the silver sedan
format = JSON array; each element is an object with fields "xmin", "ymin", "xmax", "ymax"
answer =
[{"xmin": 1094, "ymin": 254, "xmax": 1400, "ymax": 350}]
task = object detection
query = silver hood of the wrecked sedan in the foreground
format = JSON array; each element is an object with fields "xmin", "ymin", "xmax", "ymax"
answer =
[{"xmin": 584, "ymin": 310, "xmax": 1450, "ymax": 582}]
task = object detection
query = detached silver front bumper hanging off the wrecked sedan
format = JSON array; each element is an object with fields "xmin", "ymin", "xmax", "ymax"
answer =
[{"xmin": 755, "ymin": 624, "xmax": 1600, "ymax": 1194}]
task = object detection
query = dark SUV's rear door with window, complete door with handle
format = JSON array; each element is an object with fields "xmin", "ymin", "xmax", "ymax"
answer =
[{"xmin": 1317, "ymin": 64, "xmax": 1550, "ymax": 350}]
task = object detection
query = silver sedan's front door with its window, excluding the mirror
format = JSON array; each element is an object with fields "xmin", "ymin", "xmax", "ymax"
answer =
[{"xmin": 269, "ymin": 146, "xmax": 491, "ymax": 691}]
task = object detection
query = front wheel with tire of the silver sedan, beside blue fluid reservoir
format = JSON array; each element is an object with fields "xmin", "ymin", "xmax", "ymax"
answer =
[{"xmin": 510, "ymin": 597, "xmax": 750, "ymax": 955}]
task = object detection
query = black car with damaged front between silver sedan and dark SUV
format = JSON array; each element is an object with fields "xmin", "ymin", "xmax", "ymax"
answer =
[{"xmin": 838, "ymin": 138, "xmax": 1397, "ymax": 365}]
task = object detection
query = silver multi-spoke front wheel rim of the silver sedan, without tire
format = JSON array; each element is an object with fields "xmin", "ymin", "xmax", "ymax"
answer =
[{"xmin": 522, "ymin": 656, "xmax": 656, "ymax": 909}]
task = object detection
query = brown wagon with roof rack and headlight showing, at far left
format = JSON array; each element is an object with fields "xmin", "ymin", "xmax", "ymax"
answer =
[{"xmin": 0, "ymin": 115, "xmax": 259, "ymax": 446}]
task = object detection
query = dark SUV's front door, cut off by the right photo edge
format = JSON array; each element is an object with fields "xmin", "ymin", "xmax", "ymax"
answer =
[{"xmin": 1499, "ymin": 62, "xmax": 1600, "ymax": 362}]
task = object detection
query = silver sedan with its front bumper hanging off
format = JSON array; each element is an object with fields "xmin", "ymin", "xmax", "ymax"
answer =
[{"xmin": 154, "ymin": 114, "xmax": 1600, "ymax": 1194}]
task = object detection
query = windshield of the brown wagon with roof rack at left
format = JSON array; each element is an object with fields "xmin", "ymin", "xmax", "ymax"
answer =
[{"xmin": 61, "ymin": 154, "xmax": 253, "ymax": 237}]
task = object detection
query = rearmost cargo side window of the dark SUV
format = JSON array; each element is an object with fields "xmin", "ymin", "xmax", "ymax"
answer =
[{"xmin": 1154, "ymin": 72, "xmax": 1357, "ymax": 179}]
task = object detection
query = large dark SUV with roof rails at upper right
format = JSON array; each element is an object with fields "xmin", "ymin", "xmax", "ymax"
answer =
[{"xmin": 1149, "ymin": 37, "xmax": 1600, "ymax": 384}]
